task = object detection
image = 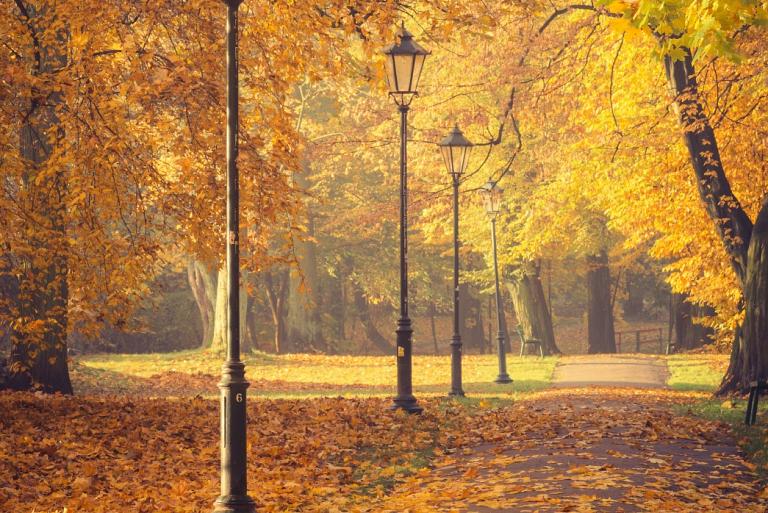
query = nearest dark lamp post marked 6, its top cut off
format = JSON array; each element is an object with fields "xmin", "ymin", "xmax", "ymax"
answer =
[{"xmin": 213, "ymin": 0, "xmax": 256, "ymax": 513}]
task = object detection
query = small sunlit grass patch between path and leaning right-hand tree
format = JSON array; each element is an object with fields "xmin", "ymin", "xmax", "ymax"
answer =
[{"xmin": 667, "ymin": 354, "xmax": 729, "ymax": 392}]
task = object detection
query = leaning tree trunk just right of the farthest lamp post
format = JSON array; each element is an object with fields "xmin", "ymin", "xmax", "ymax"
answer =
[{"xmin": 505, "ymin": 262, "xmax": 560, "ymax": 355}]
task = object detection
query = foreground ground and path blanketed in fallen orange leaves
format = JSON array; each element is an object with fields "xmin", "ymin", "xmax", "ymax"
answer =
[{"xmin": 0, "ymin": 389, "xmax": 768, "ymax": 513}]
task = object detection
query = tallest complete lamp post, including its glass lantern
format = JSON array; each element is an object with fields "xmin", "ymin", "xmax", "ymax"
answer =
[{"xmin": 384, "ymin": 24, "xmax": 429, "ymax": 413}]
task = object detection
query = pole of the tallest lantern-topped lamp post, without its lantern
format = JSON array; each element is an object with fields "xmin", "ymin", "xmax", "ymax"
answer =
[{"xmin": 393, "ymin": 102, "xmax": 422, "ymax": 413}]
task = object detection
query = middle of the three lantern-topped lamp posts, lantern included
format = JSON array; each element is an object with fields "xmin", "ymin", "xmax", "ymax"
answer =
[{"xmin": 438, "ymin": 126, "xmax": 472, "ymax": 396}]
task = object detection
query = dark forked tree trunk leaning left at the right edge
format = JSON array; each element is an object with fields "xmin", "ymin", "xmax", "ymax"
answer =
[{"xmin": 664, "ymin": 49, "xmax": 768, "ymax": 395}]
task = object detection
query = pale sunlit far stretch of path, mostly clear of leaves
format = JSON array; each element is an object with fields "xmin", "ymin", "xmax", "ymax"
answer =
[{"xmin": 552, "ymin": 355, "xmax": 667, "ymax": 388}]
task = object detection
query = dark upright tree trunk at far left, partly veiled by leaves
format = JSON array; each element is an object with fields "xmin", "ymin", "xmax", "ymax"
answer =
[{"xmin": 7, "ymin": 2, "xmax": 73, "ymax": 394}]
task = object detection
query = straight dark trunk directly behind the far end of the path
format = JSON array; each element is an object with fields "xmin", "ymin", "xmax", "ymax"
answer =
[{"xmin": 587, "ymin": 251, "xmax": 616, "ymax": 354}]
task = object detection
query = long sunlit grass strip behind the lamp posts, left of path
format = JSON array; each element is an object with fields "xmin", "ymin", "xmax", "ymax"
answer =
[{"xmin": 73, "ymin": 351, "xmax": 557, "ymax": 399}]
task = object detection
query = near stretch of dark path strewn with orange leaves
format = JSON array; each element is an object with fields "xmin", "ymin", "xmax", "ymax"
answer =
[{"xmin": 369, "ymin": 388, "xmax": 768, "ymax": 513}]
